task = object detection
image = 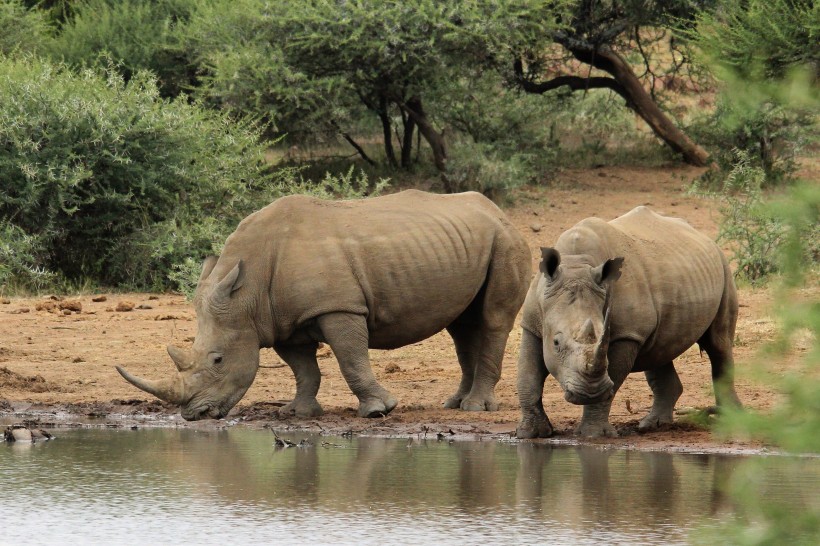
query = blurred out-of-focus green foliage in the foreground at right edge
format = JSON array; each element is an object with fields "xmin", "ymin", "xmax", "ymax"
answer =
[{"xmin": 695, "ymin": 183, "xmax": 820, "ymax": 545}]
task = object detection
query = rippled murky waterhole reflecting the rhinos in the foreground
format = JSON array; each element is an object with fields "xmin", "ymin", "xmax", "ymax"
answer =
[{"xmin": 0, "ymin": 428, "xmax": 820, "ymax": 546}]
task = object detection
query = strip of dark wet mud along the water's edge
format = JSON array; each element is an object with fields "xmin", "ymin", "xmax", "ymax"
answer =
[{"xmin": 0, "ymin": 400, "xmax": 779, "ymax": 455}]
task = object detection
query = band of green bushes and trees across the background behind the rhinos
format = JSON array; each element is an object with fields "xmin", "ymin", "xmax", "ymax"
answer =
[{"xmin": 0, "ymin": 0, "xmax": 820, "ymax": 292}]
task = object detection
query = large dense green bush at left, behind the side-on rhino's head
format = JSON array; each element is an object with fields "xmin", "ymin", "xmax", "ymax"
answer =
[{"xmin": 0, "ymin": 59, "xmax": 276, "ymax": 288}]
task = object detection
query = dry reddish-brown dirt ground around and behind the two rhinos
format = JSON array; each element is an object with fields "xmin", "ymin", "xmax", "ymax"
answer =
[{"xmin": 0, "ymin": 166, "xmax": 818, "ymax": 451}]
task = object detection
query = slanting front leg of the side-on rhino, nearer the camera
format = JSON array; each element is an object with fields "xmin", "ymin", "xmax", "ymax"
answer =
[{"xmin": 316, "ymin": 313, "xmax": 397, "ymax": 417}]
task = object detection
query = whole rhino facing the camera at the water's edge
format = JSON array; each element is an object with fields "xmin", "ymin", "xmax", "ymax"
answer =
[{"xmin": 516, "ymin": 207, "xmax": 740, "ymax": 438}]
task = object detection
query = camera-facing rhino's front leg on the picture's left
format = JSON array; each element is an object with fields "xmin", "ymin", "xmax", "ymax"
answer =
[{"xmin": 515, "ymin": 330, "xmax": 552, "ymax": 438}]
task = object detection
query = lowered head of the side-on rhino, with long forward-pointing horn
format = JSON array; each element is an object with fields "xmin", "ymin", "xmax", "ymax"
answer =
[{"xmin": 117, "ymin": 256, "xmax": 259, "ymax": 421}]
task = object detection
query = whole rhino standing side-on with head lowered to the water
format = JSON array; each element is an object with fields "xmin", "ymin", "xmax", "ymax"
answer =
[{"xmin": 117, "ymin": 190, "xmax": 530, "ymax": 420}]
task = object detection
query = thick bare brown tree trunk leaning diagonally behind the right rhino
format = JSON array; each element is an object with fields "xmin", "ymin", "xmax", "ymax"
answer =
[{"xmin": 568, "ymin": 46, "xmax": 709, "ymax": 167}]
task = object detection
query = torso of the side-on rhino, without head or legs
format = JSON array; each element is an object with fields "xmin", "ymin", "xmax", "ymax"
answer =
[{"xmin": 226, "ymin": 191, "xmax": 526, "ymax": 348}]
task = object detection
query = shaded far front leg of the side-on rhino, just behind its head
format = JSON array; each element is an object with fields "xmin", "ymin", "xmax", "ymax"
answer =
[{"xmin": 274, "ymin": 341, "xmax": 324, "ymax": 417}]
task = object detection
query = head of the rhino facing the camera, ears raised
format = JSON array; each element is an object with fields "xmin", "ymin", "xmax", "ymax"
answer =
[{"xmin": 540, "ymin": 248, "xmax": 623, "ymax": 404}]
